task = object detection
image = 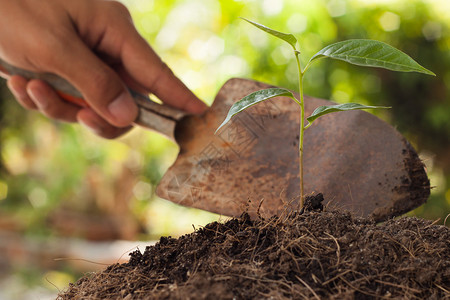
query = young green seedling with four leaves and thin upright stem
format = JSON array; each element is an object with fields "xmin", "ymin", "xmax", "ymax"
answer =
[{"xmin": 216, "ymin": 19, "xmax": 435, "ymax": 207}]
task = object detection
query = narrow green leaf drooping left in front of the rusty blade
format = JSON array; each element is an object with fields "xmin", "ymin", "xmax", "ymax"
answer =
[{"xmin": 216, "ymin": 88, "xmax": 295, "ymax": 133}]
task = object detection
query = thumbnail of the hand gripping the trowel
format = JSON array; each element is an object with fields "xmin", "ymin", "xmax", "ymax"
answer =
[{"xmin": 108, "ymin": 92, "xmax": 138, "ymax": 127}]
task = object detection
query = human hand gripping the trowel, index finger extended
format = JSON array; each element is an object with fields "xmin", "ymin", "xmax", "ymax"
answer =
[{"xmin": 0, "ymin": 0, "xmax": 206, "ymax": 138}]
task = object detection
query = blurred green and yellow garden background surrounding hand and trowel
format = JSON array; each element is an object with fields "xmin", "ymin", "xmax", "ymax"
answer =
[{"xmin": 0, "ymin": 0, "xmax": 450, "ymax": 299}]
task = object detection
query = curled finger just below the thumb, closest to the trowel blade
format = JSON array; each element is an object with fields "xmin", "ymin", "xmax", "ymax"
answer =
[{"xmin": 77, "ymin": 108, "xmax": 132, "ymax": 139}]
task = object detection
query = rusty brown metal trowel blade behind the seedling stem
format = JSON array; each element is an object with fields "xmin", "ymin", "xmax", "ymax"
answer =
[{"xmin": 157, "ymin": 79, "xmax": 430, "ymax": 221}]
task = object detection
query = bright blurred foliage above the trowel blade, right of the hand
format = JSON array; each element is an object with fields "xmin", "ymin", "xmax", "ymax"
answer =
[{"xmin": 127, "ymin": 0, "xmax": 450, "ymax": 220}]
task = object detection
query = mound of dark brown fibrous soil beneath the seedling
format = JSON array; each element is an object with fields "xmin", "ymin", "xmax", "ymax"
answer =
[{"xmin": 58, "ymin": 196, "xmax": 450, "ymax": 300}]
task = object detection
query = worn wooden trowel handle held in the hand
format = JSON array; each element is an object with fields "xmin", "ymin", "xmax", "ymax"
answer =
[{"xmin": 0, "ymin": 58, "xmax": 186, "ymax": 140}]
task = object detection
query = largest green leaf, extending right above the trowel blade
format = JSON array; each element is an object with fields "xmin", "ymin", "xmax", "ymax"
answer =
[{"xmin": 308, "ymin": 40, "xmax": 436, "ymax": 76}]
